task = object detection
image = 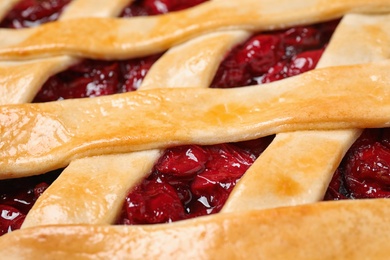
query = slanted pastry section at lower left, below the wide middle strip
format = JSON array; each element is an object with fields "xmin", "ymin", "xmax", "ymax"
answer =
[{"xmin": 22, "ymin": 150, "xmax": 161, "ymax": 228}]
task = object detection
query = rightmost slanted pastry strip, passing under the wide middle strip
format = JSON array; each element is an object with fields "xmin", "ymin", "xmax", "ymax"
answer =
[{"xmin": 222, "ymin": 14, "xmax": 390, "ymax": 212}]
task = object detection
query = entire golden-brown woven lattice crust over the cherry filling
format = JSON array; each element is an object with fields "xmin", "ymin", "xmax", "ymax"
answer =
[{"xmin": 0, "ymin": 0, "xmax": 390, "ymax": 259}]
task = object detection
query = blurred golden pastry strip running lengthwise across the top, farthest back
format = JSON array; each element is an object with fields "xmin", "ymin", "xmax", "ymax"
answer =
[{"xmin": 0, "ymin": 0, "xmax": 390, "ymax": 60}]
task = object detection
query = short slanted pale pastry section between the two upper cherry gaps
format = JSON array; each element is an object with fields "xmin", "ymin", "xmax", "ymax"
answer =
[{"xmin": 141, "ymin": 31, "xmax": 250, "ymax": 90}]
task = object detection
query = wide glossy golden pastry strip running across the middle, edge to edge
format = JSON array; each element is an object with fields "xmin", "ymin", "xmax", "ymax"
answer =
[{"xmin": 0, "ymin": 61, "xmax": 390, "ymax": 179}]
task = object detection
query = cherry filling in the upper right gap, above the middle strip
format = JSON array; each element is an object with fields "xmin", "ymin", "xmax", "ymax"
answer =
[{"xmin": 211, "ymin": 21, "xmax": 339, "ymax": 88}]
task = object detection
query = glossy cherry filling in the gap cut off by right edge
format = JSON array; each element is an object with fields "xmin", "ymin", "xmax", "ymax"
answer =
[{"xmin": 325, "ymin": 128, "xmax": 390, "ymax": 200}]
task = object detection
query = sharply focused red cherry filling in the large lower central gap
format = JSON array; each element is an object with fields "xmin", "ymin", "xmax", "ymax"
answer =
[{"xmin": 117, "ymin": 136, "xmax": 273, "ymax": 224}]
